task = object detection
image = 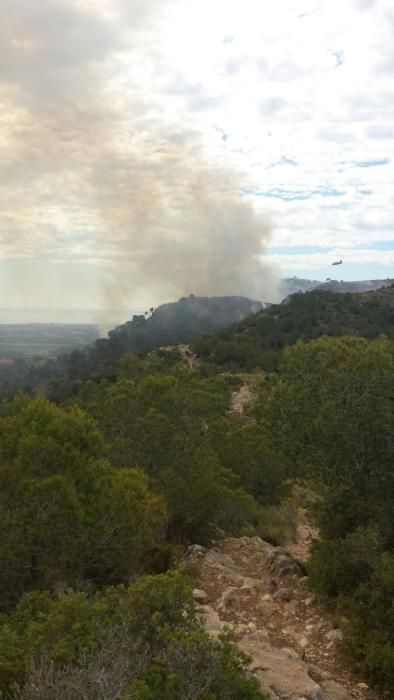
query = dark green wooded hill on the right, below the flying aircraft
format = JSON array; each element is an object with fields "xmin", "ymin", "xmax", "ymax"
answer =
[{"xmin": 193, "ymin": 285, "xmax": 394, "ymax": 371}]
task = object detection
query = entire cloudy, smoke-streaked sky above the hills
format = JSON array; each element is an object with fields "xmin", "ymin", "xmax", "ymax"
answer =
[{"xmin": 0, "ymin": 0, "xmax": 394, "ymax": 317}]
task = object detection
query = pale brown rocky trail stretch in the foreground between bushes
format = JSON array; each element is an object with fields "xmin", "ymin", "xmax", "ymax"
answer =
[{"xmin": 187, "ymin": 536, "xmax": 379, "ymax": 700}]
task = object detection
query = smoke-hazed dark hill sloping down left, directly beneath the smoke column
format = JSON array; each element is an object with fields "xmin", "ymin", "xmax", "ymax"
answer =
[{"xmin": 0, "ymin": 295, "xmax": 263, "ymax": 397}]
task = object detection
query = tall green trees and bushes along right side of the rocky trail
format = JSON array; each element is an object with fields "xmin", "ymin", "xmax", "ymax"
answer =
[{"xmin": 257, "ymin": 337, "xmax": 394, "ymax": 697}]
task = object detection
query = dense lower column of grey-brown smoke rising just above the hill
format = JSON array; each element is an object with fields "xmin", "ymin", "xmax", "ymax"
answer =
[{"xmin": 91, "ymin": 131, "xmax": 278, "ymax": 328}]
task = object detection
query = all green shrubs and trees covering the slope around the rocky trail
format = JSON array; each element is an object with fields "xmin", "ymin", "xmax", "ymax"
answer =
[{"xmin": 0, "ymin": 288, "xmax": 394, "ymax": 700}]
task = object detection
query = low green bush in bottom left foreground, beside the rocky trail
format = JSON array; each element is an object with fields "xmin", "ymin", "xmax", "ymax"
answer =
[{"xmin": 0, "ymin": 572, "xmax": 267, "ymax": 700}]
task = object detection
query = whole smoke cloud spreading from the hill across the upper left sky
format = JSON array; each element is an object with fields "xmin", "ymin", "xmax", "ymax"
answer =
[{"xmin": 0, "ymin": 0, "xmax": 277, "ymax": 326}]
